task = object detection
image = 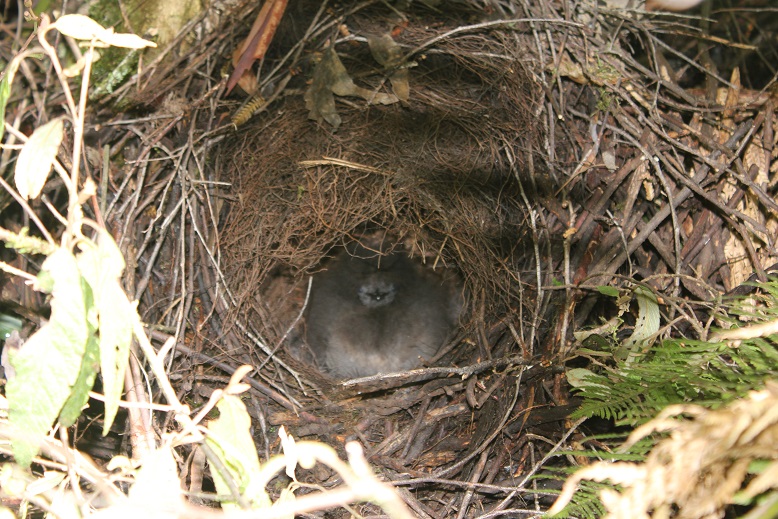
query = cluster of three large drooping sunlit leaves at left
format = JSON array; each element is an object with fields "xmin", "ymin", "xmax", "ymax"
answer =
[{"xmin": 7, "ymin": 232, "xmax": 138, "ymax": 466}]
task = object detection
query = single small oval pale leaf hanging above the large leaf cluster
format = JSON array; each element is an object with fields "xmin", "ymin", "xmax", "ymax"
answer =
[{"xmin": 14, "ymin": 118, "xmax": 65, "ymax": 200}]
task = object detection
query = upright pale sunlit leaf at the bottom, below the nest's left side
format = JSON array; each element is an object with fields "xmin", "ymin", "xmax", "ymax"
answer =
[{"xmin": 205, "ymin": 395, "xmax": 270, "ymax": 510}]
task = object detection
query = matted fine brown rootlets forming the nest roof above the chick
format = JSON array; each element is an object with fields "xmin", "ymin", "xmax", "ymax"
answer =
[{"xmin": 220, "ymin": 12, "xmax": 539, "ymax": 342}]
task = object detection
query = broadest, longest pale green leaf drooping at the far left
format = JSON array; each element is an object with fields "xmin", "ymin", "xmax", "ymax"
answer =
[{"xmin": 6, "ymin": 249, "xmax": 89, "ymax": 467}]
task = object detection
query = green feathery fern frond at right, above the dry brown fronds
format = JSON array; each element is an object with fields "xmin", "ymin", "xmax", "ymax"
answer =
[{"xmin": 571, "ymin": 280, "xmax": 778, "ymax": 427}]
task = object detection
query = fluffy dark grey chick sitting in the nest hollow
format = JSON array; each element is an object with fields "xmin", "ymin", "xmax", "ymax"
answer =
[{"xmin": 306, "ymin": 244, "xmax": 462, "ymax": 378}]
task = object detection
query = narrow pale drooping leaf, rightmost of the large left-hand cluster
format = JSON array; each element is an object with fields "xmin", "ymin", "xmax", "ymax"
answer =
[{"xmin": 78, "ymin": 231, "xmax": 138, "ymax": 434}]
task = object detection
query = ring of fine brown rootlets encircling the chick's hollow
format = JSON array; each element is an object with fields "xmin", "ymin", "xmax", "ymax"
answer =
[{"xmin": 209, "ymin": 4, "xmax": 552, "ymax": 456}]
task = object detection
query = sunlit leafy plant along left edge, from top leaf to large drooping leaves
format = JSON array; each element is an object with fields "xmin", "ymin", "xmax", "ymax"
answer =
[{"xmin": 0, "ymin": 11, "xmax": 153, "ymax": 467}]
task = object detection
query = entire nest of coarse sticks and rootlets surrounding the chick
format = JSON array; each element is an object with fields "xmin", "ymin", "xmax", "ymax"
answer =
[{"xmin": 3, "ymin": 0, "xmax": 778, "ymax": 517}]
